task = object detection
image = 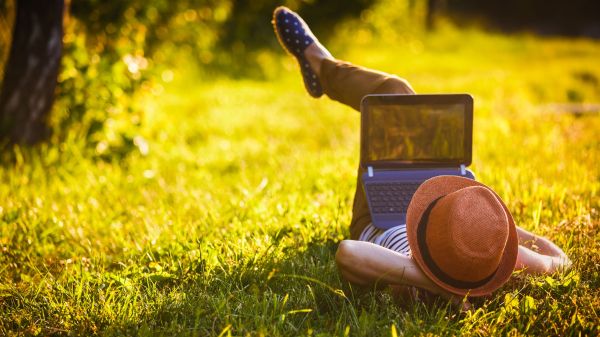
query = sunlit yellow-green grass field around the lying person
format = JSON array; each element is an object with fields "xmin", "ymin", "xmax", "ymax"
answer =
[{"xmin": 0, "ymin": 24, "xmax": 600, "ymax": 336}]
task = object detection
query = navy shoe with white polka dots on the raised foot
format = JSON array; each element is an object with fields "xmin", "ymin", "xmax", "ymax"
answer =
[{"xmin": 273, "ymin": 6, "xmax": 323, "ymax": 97}]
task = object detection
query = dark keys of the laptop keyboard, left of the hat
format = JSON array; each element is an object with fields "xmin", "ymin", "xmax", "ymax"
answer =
[{"xmin": 366, "ymin": 182, "xmax": 421, "ymax": 213}]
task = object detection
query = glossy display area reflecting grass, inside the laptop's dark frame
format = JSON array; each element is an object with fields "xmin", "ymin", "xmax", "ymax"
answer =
[{"xmin": 366, "ymin": 104, "xmax": 466, "ymax": 162}]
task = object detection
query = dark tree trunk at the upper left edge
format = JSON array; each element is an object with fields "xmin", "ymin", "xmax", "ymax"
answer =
[{"xmin": 0, "ymin": 0, "xmax": 64, "ymax": 144}]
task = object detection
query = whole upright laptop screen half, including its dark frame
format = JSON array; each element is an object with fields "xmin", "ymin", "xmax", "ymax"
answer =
[{"xmin": 361, "ymin": 94, "xmax": 473, "ymax": 167}]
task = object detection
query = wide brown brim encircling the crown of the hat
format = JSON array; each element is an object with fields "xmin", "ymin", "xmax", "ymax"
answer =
[{"xmin": 406, "ymin": 176, "xmax": 519, "ymax": 297}]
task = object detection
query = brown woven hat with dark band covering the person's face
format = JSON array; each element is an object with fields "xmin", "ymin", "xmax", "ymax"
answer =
[{"xmin": 406, "ymin": 176, "xmax": 518, "ymax": 296}]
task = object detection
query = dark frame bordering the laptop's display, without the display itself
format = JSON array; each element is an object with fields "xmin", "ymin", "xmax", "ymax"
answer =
[{"xmin": 360, "ymin": 94, "xmax": 473, "ymax": 169}]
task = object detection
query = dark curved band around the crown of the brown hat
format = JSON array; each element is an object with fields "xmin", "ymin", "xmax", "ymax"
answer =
[{"xmin": 417, "ymin": 195, "xmax": 499, "ymax": 289}]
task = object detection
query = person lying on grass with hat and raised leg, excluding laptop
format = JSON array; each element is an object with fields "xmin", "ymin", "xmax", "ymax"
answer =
[{"xmin": 273, "ymin": 7, "xmax": 571, "ymax": 306}]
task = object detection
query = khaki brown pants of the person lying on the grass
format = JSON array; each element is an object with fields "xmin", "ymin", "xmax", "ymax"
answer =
[{"xmin": 320, "ymin": 59, "xmax": 415, "ymax": 240}]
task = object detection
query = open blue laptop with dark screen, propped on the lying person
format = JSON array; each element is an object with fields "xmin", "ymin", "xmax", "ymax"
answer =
[{"xmin": 360, "ymin": 94, "xmax": 475, "ymax": 229}]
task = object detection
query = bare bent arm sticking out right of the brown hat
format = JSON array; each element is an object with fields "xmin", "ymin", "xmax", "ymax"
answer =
[{"xmin": 515, "ymin": 226, "xmax": 571, "ymax": 274}]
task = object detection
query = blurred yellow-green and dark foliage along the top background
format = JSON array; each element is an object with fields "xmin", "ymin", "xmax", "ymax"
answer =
[{"xmin": 0, "ymin": 0, "xmax": 600, "ymax": 158}]
